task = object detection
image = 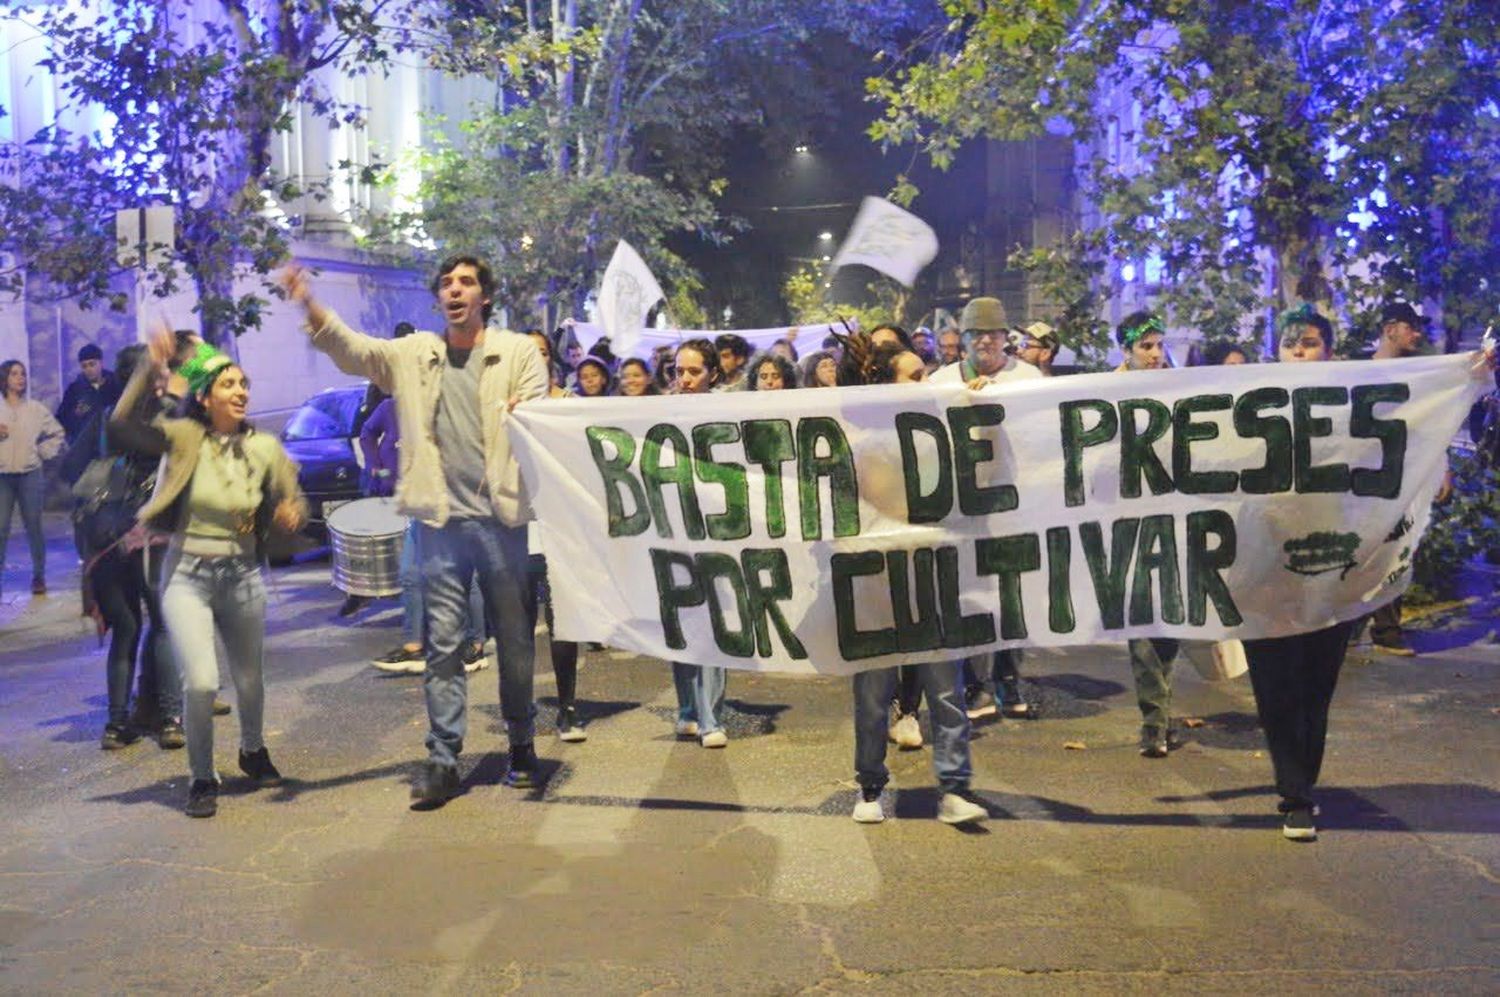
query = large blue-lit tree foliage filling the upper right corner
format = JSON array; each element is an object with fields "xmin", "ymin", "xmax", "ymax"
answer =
[{"xmin": 869, "ymin": 0, "xmax": 1500, "ymax": 358}]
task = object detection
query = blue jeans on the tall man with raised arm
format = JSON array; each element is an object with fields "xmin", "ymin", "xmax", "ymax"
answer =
[{"xmin": 417, "ymin": 519, "xmax": 537, "ymax": 765}]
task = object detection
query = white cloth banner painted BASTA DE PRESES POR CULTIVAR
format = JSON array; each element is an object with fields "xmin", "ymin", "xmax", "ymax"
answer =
[{"xmin": 510, "ymin": 357, "xmax": 1488, "ymax": 673}]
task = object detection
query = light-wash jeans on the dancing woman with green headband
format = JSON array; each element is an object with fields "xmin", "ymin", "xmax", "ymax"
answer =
[{"xmin": 162, "ymin": 555, "xmax": 266, "ymax": 780}]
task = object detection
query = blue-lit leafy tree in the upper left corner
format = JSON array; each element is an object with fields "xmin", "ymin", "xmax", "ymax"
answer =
[{"xmin": 0, "ymin": 0, "xmax": 395, "ymax": 342}]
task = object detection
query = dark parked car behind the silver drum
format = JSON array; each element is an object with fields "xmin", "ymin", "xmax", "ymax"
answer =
[{"xmin": 281, "ymin": 384, "xmax": 378, "ymax": 540}]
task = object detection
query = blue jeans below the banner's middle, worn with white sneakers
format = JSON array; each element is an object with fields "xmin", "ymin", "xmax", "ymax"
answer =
[{"xmin": 854, "ymin": 660, "xmax": 974, "ymax": 793}]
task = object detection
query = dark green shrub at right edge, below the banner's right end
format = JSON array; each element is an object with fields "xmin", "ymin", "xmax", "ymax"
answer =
[{"xmin": 1409, "ymin": 453, "xmax": 1500, "ymax": 604}]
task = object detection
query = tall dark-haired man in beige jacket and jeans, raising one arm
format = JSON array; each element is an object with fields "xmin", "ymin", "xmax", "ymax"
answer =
[{"xmin": 282, "ymin": 256, "xmax": 548, "ymax": 810}]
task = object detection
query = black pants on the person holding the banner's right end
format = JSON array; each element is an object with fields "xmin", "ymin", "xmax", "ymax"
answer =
[{"xmin": 1245, "ymin": 624, "xmax": 1352, "ymax": 811}]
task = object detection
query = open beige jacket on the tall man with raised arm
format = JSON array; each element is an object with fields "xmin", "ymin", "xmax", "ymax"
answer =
[{"xmin": 311, "ymin": 312, "xmax": 548, "ymax": 526}]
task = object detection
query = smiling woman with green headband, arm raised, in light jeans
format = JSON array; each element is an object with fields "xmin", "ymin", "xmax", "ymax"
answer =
[{"xmin": 111, "ymin": 330, "xmax": 306, "ymax": 817}]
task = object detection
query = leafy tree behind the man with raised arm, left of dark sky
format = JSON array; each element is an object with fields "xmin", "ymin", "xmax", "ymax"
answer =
[{"xmin": 371, "ymin": 0, "xmax": 906, "ymax": 321}]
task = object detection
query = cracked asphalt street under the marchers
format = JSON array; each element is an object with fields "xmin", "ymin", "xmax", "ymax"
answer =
[{"xmin": 0, "ymin": 519, "xmax": 1500, "ymax": 994}]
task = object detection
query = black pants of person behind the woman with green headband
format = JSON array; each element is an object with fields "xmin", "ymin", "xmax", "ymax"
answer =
[{"xmin": 92, "ymin": 549, "xmax": 183, "ymax": 724}]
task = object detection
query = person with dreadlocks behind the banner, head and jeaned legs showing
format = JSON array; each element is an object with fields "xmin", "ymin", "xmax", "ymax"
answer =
[{"xmin": 839, "ymin": 333, "xmax": 990, "ymax": 825}]
